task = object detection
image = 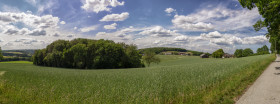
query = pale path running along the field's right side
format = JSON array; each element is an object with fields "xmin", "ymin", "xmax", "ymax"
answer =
[{"xmin": 236, "ymin": 55, "xmax": 280, "ymax": 104}]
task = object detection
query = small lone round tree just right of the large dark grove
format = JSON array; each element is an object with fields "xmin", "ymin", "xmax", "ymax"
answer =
[{"xmin": 143, "ymin": 50, "xmax": 160, "ymax": 66}]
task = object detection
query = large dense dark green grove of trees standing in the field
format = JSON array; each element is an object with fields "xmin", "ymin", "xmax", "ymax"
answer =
[{"xmin": 33, "ymin": 39, "xmax": 143, "ymax": 69}]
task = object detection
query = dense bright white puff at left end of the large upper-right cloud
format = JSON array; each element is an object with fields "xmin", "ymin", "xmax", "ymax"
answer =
[{"xmin": 172, "ymin": 15, "xmax": 214, "ymax": 31}]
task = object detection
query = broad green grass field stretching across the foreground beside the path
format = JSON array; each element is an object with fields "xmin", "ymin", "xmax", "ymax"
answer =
[{"xmin": 0, "ymin": 55, "xmax": 275, "ymax": 104}]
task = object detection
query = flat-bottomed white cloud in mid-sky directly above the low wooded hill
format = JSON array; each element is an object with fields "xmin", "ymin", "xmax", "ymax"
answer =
[{"xmin": 140, "ymin": 26, "xmax": 176, "ymax": 37}]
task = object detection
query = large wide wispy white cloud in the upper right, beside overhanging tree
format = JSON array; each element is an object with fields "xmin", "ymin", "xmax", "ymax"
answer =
[{"xmin": 172, "ymin": 5, "xmax": 261, "ymax": 31}]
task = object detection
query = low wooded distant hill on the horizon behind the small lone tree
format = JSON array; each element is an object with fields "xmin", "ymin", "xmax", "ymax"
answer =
[{"xmin": 139, "ymin": 47, "xmax": 203, "ymax": 56}]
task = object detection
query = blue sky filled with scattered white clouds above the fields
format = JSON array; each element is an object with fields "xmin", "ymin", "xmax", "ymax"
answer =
[{"xmin": 0, "ymin": 0, "xmax": 270, "ymax": 53}]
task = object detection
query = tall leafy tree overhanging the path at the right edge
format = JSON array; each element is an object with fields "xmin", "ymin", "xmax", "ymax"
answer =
[{"xmin": 239, "ymin": 0, "xmax": 280, "ymax": 54}]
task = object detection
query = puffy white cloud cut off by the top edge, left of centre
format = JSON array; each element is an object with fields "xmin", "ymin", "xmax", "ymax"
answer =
[{"xmin": 82, "ymin": 0, "xmax": 124, "ymax": 13}]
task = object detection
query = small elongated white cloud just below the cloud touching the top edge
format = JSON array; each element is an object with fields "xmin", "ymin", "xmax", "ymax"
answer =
[{"xmin": 100, "ymin": 12, "xmax": 129, "ymax": 21}]
